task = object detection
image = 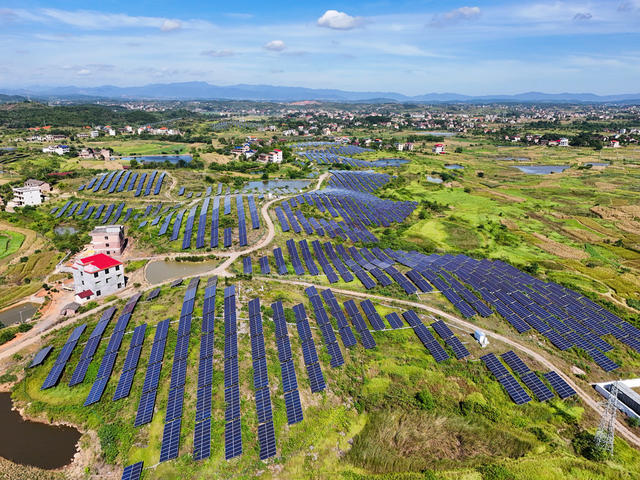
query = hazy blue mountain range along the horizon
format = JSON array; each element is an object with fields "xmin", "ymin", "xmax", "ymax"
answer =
[{"xmin": 0, "ymin": 82, "xmax": 640, "ymax": 103}]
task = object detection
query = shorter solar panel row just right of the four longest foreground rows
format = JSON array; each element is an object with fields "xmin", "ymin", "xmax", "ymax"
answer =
[{"xmin": 271, "ymin": 301, "xmax": 303, "ymax": 425}]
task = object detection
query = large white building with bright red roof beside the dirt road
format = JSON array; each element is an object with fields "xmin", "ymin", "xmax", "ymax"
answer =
[{"xmin": 72, "ymin": 253, "xmax": 125, "ymax": 303}]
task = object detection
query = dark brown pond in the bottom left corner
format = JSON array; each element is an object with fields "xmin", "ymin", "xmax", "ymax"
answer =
[{"xmin": 0, "ymin": 393, "xmax": 80, "ymax": 470}]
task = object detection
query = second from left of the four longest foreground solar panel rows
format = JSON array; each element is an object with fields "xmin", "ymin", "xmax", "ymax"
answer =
[{"xmin": 193, "ymin": 277, "xmax": 218, "ymax": 460}]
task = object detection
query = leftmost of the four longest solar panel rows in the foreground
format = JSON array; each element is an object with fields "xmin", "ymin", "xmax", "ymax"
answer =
[{"xmin": 160, "ymin": 278, "xmax": 200, "ymax": 462}]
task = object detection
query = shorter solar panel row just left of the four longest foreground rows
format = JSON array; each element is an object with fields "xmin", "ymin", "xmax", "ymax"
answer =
[{"xmin": 134, "ymin": 318, "xmax": 171, "ymax": 427}]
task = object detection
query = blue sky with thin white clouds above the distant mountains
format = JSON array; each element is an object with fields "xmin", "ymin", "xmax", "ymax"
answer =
[{"xmin": 0, "ymin": 0, "xmax": 640, "ymax": 95}]
